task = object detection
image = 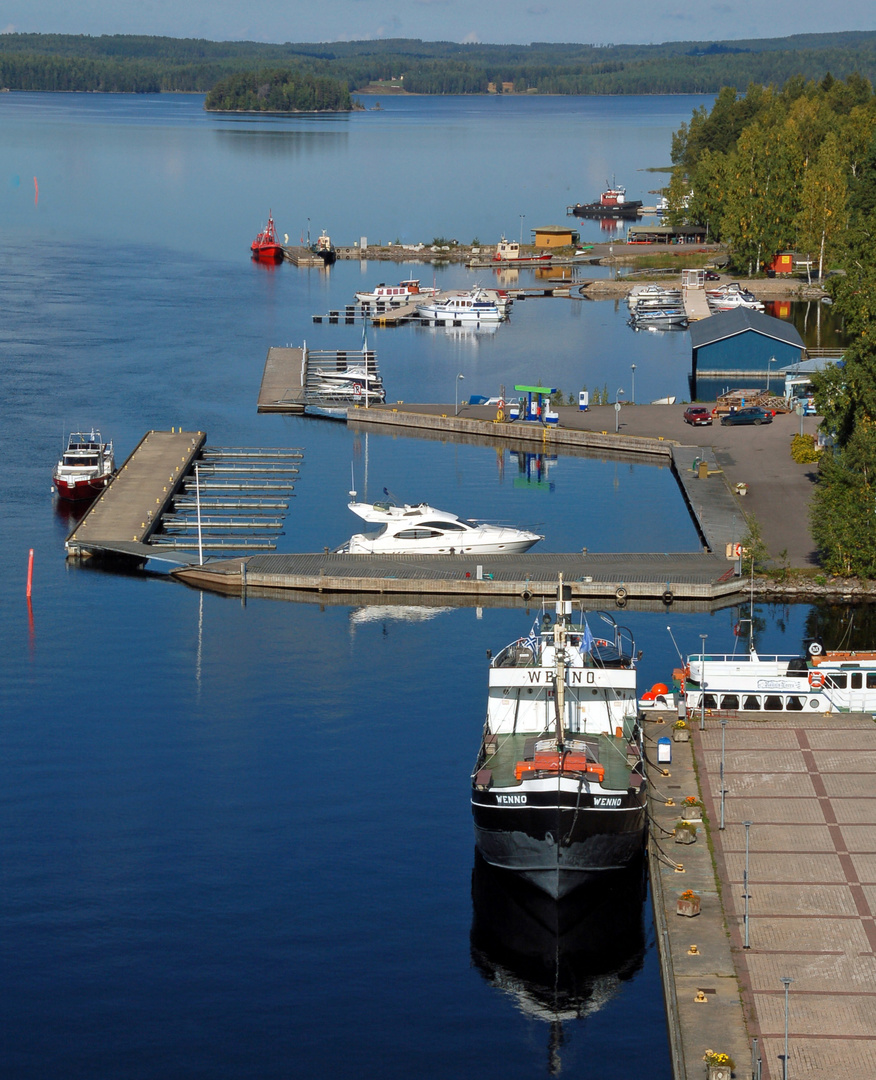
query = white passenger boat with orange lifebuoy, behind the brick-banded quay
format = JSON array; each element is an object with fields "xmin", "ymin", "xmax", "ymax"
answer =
[{"xmin": 682, "ymin": 642, "xmax": 876, "ymax": 713}]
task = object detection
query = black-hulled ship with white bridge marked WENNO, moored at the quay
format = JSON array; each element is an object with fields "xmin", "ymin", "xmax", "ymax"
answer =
[{"xmin": 471, "ymin": 576, "xmax": 646, "ymax": 899}]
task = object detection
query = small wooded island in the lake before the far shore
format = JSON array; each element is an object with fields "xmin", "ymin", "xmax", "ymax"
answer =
[{"xmin": 204, "ymin": 68, "xmax": 353, "ymax": 112}]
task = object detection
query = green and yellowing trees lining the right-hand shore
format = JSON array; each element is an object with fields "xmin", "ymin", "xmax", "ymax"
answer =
[{"xmin": 669, "ymin": 76, "xmax": 876, "ymax": 578}]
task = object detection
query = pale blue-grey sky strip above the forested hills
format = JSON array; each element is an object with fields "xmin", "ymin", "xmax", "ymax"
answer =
[{"xmin": 0, "ymin": 0, "xmax": 876, "ymax": 44}]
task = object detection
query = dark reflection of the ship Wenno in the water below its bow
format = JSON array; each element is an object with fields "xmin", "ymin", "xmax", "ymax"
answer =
[{"xmin": 471, "ymin": 851, "xmax": 645, "ymax": 1076}]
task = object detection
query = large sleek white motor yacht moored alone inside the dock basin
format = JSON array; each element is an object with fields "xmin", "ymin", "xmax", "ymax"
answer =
[{"xmin": 336, "ymin": 492, "xmax": 544, "ymax": 555}]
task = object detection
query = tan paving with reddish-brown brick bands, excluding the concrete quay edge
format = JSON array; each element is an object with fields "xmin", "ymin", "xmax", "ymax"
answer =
[{"xmin": 695, "ymin": 714, "xmax": 876, "ymax": 1080}]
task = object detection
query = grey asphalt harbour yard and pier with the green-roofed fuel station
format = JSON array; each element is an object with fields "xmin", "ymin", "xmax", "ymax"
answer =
[{"xmin": 348, "ymin": 402, "xmax": 819, "ymax": 568}]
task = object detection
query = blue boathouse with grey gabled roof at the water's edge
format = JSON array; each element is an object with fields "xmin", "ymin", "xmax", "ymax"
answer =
[{"xmin": 690, "ymin": 308, "xmax": 805, "ymax": 396}]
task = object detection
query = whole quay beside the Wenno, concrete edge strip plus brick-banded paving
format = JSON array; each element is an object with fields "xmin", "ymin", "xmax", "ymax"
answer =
[{"xmin": 645, "ymin": 713, "xmax": 876, "ymax": 1080}]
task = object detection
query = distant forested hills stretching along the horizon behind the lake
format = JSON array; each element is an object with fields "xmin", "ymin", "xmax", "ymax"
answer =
[{"xmin": 0, "ymin": 31, "xmax": 876, "ymax": 94}]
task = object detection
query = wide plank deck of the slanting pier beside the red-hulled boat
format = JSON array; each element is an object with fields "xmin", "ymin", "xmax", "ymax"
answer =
[{"xmin": 65, "ymin": 429, "xmax": 206, "ymax": 555}]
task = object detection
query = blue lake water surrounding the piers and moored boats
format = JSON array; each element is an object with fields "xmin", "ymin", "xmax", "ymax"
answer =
[{"xmin": 0, "ymin": 94, "xmax": 851, "ymax": 1080}]
